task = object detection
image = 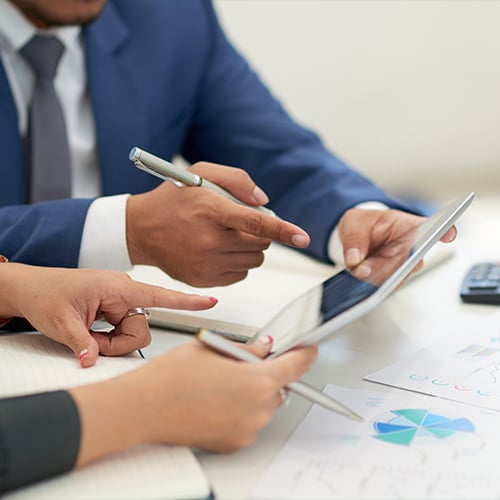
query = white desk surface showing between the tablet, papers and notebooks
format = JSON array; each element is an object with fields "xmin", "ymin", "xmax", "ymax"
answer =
[{"xmin": 146, "ymin": 196, "xmax": 500, "ymax": 500}]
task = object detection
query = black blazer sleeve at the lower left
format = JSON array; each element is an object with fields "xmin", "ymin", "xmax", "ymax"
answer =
[{"xmin": 0, "ymin": 391, "xmax": 80, "ymax": 491}]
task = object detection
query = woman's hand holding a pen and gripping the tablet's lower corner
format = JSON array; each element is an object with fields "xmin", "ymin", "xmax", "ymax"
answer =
[{"xmin": 133, "ymin": 337, "xmax": 317, "ymax": 452}]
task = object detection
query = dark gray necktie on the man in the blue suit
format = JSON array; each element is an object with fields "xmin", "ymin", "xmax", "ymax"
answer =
[{"xmin": 20, "ymin": 35, "xmax": 71, "ymax": 203}]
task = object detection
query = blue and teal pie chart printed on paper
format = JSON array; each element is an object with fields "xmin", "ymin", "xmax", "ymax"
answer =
[{"xmin": 373, "ymin": 409, "xmax": 475, "ymax": 446}]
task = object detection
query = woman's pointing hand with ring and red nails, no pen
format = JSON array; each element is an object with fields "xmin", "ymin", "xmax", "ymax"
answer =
[{"xmin": 0, "ymin": 263, "xmax": 217, "ymax": 367}]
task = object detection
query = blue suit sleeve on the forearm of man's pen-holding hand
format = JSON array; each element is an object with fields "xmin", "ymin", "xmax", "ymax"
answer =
[{"xmin": 0, "ymin": 199, "xmax": 93, "ymax": 267}]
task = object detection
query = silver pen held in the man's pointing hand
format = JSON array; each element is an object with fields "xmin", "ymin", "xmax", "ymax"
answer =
[{"xmin": 129, "ymin": 147, "xmax": 276, "ymax": 217}]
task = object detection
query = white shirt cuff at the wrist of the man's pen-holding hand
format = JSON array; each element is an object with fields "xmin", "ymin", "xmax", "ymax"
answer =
[{"xmin": 78, "ymin": 194, "xmax": 132, "ymax": 271}]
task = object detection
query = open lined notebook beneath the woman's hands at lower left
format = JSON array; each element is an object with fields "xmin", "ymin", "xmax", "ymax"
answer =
[{"xmin": 0, "ymin": 333, "xmax": 211, "ymax": 500}]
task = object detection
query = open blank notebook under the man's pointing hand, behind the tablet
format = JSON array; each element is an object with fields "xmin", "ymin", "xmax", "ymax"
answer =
[{"xmin": 129, "ymin": 243, "xmax": 340, "ymax": 341}]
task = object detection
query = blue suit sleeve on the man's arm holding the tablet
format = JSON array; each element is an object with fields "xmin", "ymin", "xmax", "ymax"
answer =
[{"xmin": 183, "ymin": 2, "xmax": 418, "ymax": 261}]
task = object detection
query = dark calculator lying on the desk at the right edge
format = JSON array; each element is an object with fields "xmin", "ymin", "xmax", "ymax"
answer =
[{"xmin": 460, "ymin": 262, "xmax": 500, "ymax": 305}]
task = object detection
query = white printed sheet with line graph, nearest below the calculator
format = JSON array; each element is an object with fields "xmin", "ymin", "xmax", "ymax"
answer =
[{"xmin": 365, "ymin": 311, "xmax": 500, "ymax": 410}]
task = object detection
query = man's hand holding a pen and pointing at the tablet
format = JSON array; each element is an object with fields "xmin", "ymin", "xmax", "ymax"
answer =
[{"xmin": 127, "ymin": 163, "xmax": 310, "ymax": 287}]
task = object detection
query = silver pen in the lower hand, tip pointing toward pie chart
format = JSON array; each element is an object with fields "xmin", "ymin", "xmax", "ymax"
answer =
[{"xmin": 196, "ymin": 328, "xmax": 364, "ymax": 422}]
